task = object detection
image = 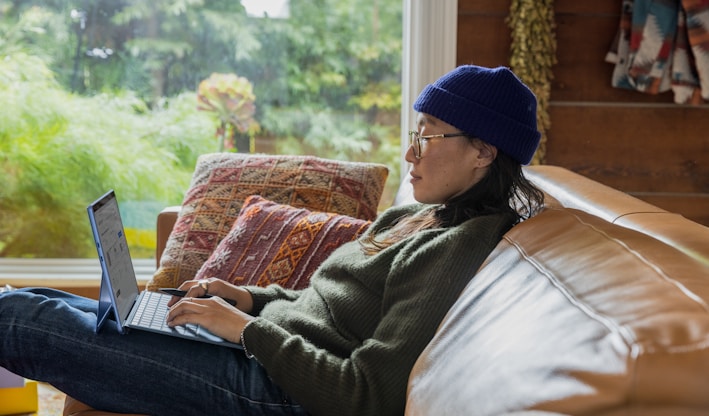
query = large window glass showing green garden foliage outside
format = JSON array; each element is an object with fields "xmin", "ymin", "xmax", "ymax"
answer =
[{"xmin": 0, "ymin": 0, "xmax": 402, "ymax": 258}]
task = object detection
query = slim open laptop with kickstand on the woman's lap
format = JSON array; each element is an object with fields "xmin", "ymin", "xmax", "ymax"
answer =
[{"xmin": 87, "ymin": 190, "xmax": 242, "ymax": 348}]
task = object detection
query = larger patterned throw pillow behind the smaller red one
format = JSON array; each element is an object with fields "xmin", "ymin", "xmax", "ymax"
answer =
[{"xmin": 146, "ymin": 153, "xmax": 389, "ymax": 290}]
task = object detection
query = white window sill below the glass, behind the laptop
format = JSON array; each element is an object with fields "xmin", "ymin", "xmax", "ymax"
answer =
[{"xmin": 0, "ymin": 258, "xmax": 155, "ymax": 289}]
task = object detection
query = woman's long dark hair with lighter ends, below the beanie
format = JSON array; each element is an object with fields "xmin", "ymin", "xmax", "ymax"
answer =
[{"xmin": 360, "ymin": 150, "xmax": 544, "ymax": 254}]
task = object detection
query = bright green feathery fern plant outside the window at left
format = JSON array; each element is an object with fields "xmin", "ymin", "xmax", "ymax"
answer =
[{"xmin": 0, "ymin": 54, "xmax": 212, "ymax": 257}]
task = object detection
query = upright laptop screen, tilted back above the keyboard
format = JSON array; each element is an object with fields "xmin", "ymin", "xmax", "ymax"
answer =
[{"xmin": 89, "ymin": 191, "xmax": 139, "ymax": 324}]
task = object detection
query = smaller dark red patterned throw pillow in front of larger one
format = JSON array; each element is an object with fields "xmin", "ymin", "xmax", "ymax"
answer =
[{"xmin": 196, "ymin": 195, "xmax": 370, "ymax": 289}]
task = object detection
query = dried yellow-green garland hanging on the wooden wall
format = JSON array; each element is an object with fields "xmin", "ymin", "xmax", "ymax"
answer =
[{"xmin": 507, "ymin": 0, "xmax": 556, "ymax": 165}]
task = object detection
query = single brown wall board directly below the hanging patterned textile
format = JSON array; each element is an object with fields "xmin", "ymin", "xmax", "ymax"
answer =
[{"xmin": 547, "ymin": 104, "xmax": 709, "ymax": 193}]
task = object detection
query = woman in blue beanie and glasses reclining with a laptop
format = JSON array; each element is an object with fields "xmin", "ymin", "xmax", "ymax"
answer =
[{"xmin": 0, "ymin": 66, "xmax": 543, "ymax": 415}]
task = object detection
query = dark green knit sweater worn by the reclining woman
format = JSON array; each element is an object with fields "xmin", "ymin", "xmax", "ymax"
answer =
[{"xmin": 244, "ymin": 204, "xmax": 511, "ymax": 416}]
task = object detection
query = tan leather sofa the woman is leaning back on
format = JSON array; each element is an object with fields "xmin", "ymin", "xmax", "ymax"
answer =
[{"xmin": 64, "ymin": 166, "xmax": 709, "ymax": 416}]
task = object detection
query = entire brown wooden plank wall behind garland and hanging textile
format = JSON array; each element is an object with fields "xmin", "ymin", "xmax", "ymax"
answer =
[{"xmin": 457, "ymin": 0, "xmax": 709, "ymax": 225}]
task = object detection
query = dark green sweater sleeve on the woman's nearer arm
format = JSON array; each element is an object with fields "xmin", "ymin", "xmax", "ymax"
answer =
[{"xmin": 244, "ymin": 211, "xmax": 510, "ymax": 416}]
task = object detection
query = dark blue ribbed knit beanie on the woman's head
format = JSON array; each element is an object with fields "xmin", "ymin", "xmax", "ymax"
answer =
[{"xmin": 414, "ymin": 65, "xmax": 541, "ymax": 165}]
